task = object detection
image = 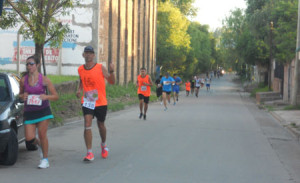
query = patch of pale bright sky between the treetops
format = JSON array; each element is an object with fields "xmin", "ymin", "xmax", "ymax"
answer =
[{"xmin": 192, "ymin": 0, "xmax": 246, "ymax": 30}]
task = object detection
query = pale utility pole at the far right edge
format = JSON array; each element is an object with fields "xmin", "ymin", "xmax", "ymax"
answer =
[{"xmin": 291, "ymin": 0, "xmax": 300, "ymax": 106}]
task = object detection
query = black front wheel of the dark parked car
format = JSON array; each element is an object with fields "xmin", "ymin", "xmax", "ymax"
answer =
[{"xmin": 1, "ymin": 129, "xmax": 19, "ymax": 165}]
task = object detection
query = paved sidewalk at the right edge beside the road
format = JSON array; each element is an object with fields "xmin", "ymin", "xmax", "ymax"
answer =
[{"xmin": 270, "ymin": 110, "xmax": 300, "ymax": 138}]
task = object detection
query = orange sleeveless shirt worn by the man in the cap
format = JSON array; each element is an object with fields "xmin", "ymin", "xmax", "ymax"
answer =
[{"xmin": 78, "ymin": 63, "xmax": 107, "ymax": 107}]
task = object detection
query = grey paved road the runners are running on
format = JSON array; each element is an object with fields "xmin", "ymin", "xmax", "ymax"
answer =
[{"xmin": 0, "ymin": 75, "xmax": 300, "ymax": 183}]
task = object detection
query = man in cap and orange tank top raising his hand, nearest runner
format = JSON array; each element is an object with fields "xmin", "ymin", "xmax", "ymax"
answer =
[{"xmin": 76, "ymin": 46, "xmax": 115, "ymax": 161}]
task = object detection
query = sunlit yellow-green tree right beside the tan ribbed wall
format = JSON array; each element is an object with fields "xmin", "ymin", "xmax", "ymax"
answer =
[{"xmin": 157, "ymin": 2, "xmax": 190, "ymax": 74}]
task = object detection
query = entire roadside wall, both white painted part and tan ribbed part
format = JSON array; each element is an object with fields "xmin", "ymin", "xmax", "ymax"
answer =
[{"xmin": 0, "ymin": 0, "xmax": 157, "ymax": 84}]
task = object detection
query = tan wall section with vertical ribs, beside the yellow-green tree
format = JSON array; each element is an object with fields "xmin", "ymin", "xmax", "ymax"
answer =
[{"xmin": 98, "ymin": 0, "xmax": 157, "ymax": 84}]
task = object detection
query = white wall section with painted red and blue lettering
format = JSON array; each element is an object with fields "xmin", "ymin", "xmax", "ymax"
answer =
[{"xmin": 0, "ymin": 0, "xmax": 98, "ymax": 75}]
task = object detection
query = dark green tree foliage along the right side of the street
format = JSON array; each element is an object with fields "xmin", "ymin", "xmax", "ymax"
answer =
[{"xmin": 220, "ymin": 0, "xmax": 298, "ymax": 79}]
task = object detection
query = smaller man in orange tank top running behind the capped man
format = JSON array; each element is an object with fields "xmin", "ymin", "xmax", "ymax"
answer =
[{"xmin": 136, "ymin": 67, "xmax": 152, "ymax": 120}]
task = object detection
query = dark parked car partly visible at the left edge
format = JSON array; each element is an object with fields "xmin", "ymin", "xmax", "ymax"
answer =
[{"xmin": 0, "ymin": 73, "xmax": 25, "ymax": 165}]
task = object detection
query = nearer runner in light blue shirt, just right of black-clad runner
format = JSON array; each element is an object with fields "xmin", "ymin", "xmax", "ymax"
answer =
[{"xmin": 160, "ymin": 73, "xmax": 175, "ymax": 111}]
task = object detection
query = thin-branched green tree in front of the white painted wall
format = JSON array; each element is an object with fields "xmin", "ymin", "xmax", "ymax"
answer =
[{"xmin": 0, "ymin": 0, "xmax": 79, "ymax": 68}]
